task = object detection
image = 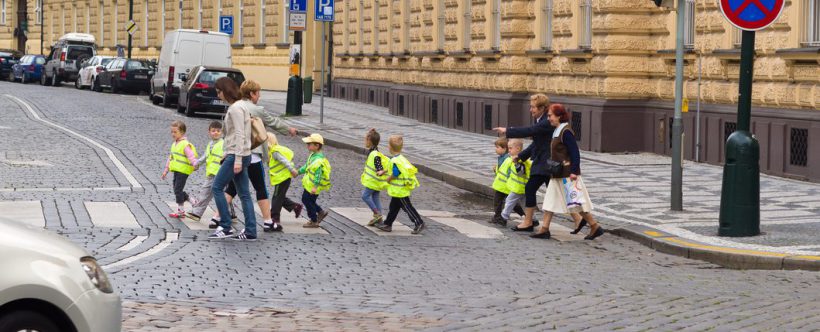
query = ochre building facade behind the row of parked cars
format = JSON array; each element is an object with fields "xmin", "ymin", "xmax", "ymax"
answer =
[{"xmin": 0, "ymin": 0, "xmax": 330, "ymax": 90}]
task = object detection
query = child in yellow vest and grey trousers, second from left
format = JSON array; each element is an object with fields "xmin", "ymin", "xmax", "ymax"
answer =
[{"xmin": 188, "ymin": 121, "xmax": 225, "ymax": 228}]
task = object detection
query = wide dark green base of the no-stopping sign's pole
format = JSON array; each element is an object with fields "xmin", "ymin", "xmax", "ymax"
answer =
[{"xmin": 718, "ymin": 130, "xmax": 760, "ymax": 236}]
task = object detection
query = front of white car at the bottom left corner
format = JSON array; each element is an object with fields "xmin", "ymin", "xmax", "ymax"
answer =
[{"xmin": 0, "ymin": 219, "xmax": 122, "ymax": 332}]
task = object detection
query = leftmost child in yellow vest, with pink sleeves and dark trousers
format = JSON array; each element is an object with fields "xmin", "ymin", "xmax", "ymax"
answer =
[{"xmin": 161, "ymin": 120, "xmax": 199, "ymax": 218}]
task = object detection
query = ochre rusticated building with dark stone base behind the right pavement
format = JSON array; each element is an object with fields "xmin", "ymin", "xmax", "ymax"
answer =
[{"xmin": 333, "ymin": 0, "xmax": 820, "ymax": 181}]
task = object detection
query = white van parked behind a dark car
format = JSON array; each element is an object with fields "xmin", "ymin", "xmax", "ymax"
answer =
[{"xmin": 148, "ymin": 29, "xmax": 231, "ymax": 107}]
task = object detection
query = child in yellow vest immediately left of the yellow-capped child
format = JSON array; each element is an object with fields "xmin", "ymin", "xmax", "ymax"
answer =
[{"xmin": 262, "ymin": 132, "xmax": 302, "ymax": 232}]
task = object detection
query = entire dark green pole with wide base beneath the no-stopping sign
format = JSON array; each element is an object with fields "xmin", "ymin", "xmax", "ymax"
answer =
[{"xmin": 718, "ymin": 31, "xmax": 760, "ymax": 236}]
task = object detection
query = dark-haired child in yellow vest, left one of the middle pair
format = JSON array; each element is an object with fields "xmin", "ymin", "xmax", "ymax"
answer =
[{"xmin": 361, "ymin": 128, "xmax": 388, "ymax": 226}]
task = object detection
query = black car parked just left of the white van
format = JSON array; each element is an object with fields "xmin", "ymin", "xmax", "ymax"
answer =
[{"xmin": 93, "ymin": 58, "xmax": 153, "ymax": 93}]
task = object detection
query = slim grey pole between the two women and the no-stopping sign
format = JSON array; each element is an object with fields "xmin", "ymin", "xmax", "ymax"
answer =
[{"xmin": 671, "ymin": 0, "xmax": 686, "ymax": 211}]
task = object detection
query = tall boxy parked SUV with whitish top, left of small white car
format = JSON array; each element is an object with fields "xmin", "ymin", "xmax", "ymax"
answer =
[{"xmin": 40, "ymin": 33, "xmax": 97, "ymax": 86}]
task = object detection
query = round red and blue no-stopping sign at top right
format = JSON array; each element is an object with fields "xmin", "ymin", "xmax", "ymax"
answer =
[{"xmin": 720, "ymin": 0, "xmax": 786, "ymax": 31}]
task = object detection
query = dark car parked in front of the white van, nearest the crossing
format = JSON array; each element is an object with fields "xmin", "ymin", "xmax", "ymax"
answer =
[{"xmin": 177, "ymin": 66, "xmax": 245, "ymax": 116}]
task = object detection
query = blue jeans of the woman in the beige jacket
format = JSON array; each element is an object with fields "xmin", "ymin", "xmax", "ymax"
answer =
[{"xmin": 211, "ymin": 154, "xmax": 256, "ymax": 235}]
